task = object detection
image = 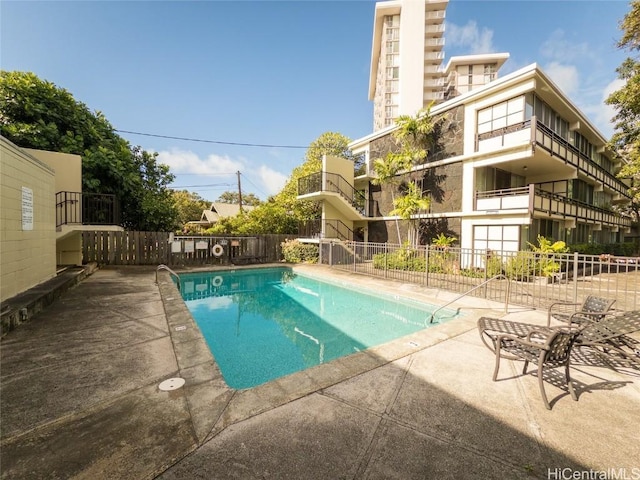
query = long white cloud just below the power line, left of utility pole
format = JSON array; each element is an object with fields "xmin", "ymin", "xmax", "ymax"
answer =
[{"xmin": 158, "ymin": 148, "xmax": 245, "ymax": 175}]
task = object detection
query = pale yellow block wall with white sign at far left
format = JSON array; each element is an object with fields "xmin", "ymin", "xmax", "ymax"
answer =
[{"xmin": 0, "ymin": 137, "xmax": 56, "ymax": 301}]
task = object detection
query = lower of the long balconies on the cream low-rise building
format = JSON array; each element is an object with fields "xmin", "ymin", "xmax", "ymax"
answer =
[{"xmin": 475, "ymin": 183, "xmax": 631, "ymax": 227}]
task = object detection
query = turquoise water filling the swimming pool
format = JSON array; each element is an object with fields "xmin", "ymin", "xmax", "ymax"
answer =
[{"xmin": 180, "ymin": 268, "xmax": 456, "ymax": 389}]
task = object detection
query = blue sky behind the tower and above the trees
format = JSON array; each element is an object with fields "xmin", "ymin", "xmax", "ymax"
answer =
[{"xmin": 0, "ymin": 0, "xmax": 629, "ymax": 200}]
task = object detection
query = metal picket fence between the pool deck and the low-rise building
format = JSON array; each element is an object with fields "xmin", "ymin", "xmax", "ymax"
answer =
[{"xmin": 320, "ymin": 241, "xmax": 640, "ymax": 310}]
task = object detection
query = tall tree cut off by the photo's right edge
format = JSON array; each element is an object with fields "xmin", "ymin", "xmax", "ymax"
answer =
[{"xmin": 606, "ymin": 0, "xmax": 640, "ymax": 221}]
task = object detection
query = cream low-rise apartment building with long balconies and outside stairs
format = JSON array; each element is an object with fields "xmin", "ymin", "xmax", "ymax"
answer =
[{"xmin": 299, "ymin": 62, "xmax": 631, "ymax": 251}]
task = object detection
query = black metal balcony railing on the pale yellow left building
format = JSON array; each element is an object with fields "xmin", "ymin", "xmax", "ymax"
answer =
[{"xmin": 56, "ymin": 192, "xmax": 120, "ymax": 227}]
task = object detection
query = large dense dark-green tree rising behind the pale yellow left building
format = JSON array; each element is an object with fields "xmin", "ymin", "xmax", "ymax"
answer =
[{"xmin": 0, "ymin": 71, "xmax": 177, "ymax": 230}]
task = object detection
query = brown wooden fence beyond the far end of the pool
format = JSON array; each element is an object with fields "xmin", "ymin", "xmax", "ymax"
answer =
[{"xmin": 82, "ymin": 231, "xmax": 296, "ymax": 266}]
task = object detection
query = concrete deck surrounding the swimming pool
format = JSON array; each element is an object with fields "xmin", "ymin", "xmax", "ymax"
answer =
[{"xmin": 0, "ymin": 266, "xmax": 640, "ymax": 480}]
